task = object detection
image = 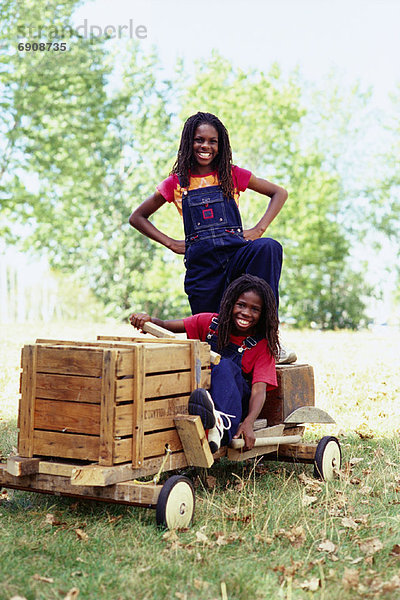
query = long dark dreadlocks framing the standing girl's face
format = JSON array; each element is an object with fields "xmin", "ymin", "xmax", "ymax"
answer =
[{"xmin": 170, "ymin": 112, "xmax": 233, "ymax": 198}]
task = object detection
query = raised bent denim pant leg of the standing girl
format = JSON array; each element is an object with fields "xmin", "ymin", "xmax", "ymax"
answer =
[{"xmin": 227, "ymin": 238, "xmax": 283, "ymax": 306}]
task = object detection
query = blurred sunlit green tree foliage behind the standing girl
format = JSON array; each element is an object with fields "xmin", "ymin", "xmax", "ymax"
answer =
[{"xmin": 0, "ymin": 9, "xmax": 374, "ymax": 328}]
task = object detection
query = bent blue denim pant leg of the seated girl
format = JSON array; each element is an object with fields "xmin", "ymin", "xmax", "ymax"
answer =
[{"xmin": 210, "ymin": 358, "xmax": 250, "ymax": 443}]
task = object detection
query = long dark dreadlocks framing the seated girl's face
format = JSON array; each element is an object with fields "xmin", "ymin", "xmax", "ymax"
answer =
[{"xmin": 218, "ymin": 275, "xmax": 280, "ymax": 358}]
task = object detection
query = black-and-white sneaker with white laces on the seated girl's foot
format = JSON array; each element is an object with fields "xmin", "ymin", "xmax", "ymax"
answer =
[{"xmin": 188, "ymin": 388, "xmax": 235, "ymax": 454}]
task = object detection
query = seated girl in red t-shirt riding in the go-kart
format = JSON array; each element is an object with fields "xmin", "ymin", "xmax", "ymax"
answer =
[{"xmin": 130, "ymin": 275, "xmax": 280, "ymax": 453}]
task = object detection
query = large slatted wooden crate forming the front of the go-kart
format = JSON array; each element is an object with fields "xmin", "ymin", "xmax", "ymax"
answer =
[{"xmin": 18, "ymin": 339, "xmax": 210, "ymax": 468}]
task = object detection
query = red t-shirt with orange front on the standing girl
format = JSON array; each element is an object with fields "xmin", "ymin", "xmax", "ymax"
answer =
[{"xmin": 157, "ymin": 165, "xmax": 251, "ymax": 214}]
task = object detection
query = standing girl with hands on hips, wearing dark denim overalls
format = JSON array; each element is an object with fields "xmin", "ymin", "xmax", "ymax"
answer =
[{"xmin": 129, "ymin": 112, "xmax": 287, "ymax": 314}]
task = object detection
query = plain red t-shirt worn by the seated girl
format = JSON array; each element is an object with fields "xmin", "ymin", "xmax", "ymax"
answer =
[{"xmin": 183, "ymin": 313, "xmax": 278, "ymax": 390}]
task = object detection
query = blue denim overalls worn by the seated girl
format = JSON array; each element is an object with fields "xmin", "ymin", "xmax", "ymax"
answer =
[{"xmin": 206, "ymin": 317, "xmax": 259, "ymax": 444}]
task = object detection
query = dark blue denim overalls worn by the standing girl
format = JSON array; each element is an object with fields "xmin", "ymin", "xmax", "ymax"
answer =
[{"xmin": 182, "ymin": 185, "xmax": 282, "ymax": 314}]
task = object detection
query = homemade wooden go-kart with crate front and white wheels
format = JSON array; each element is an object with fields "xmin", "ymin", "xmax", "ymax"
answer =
[{"xmin": 0, "ymin": 323, "xmax": 341, "ymax": 529}]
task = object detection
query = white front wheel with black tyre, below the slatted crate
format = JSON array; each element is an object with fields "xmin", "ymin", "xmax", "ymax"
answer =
[{"xmin": 156, "ymin": 475, "xmax": 195, "ymax": 529}]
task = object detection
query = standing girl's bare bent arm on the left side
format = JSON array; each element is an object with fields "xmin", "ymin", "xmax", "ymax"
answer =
[{"xmin": 129, "ymin": 191, "xmax": 185, "ymax": 254}]
